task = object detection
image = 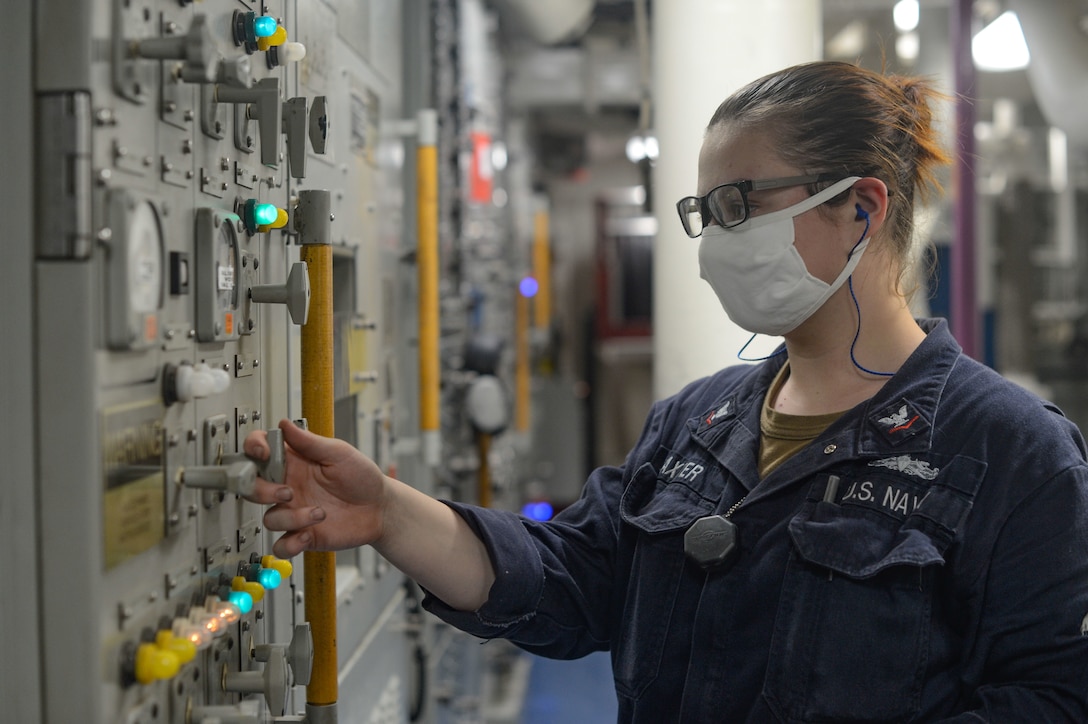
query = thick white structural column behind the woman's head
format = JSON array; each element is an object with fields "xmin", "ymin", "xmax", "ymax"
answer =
[{"xmin": 651, "ymin": 0, "xmax": 823, "ymax": 400}]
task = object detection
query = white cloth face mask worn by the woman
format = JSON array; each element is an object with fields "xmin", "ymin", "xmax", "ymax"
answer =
[{"xmin": 698, "ymin": 176, "xmax": 869, "ymax": 335}]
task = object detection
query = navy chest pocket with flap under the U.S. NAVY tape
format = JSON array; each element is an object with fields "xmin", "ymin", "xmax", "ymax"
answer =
[{"xmin": 764, "ymin": 472, "xmax": 969, "ymax": 722}]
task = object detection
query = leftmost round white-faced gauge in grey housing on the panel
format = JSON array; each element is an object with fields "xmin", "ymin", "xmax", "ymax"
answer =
[{"xmin": 107, "ymin": 189, "xmax": 165, "ymax": 349}]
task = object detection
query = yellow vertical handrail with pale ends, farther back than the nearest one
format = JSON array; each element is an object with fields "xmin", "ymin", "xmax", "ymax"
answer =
[{"xmin": 416, "ymin": 109, "xmax": 442, "ymax": 467}]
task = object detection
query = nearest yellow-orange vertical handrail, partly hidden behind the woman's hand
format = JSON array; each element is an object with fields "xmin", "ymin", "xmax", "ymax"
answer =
[{"xmin": 295, "ymin": 191, "xmax": 337, "ymax": 722}]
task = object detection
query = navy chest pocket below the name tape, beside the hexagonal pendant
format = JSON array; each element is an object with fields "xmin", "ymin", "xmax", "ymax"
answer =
[{"xmin": 613, "ymin": 463, "xmax": 720, "ymax": 699}]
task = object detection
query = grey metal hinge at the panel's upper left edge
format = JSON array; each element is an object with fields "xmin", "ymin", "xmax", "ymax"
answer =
[{"xmin": 36, "ymin": 91, "xmax": 94, "ymax": 259}]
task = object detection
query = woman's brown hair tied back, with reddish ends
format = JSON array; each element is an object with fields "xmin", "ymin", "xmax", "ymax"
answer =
[{"xmin": 707, "ymin": 61, "xmax": 949, "ymax": 267}]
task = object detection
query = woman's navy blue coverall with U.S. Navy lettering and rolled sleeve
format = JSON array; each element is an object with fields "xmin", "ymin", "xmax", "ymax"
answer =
[{"xmin": 425, "ymin": 320, "xmax": 1088, "ymax": 724}]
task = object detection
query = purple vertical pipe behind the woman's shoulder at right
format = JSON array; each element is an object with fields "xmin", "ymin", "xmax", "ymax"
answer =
[{"xmin": 950, "ymin": 0, "xmax": 978, "ymax": 359}]
